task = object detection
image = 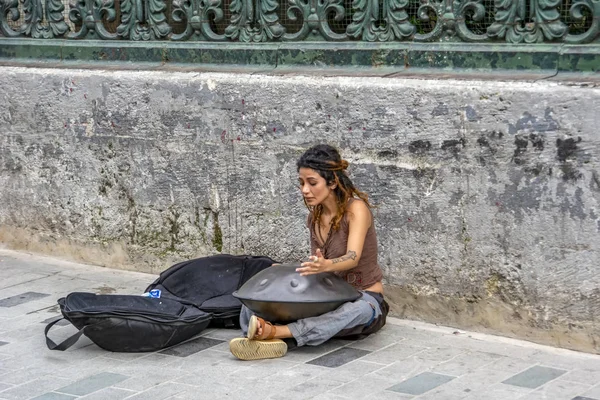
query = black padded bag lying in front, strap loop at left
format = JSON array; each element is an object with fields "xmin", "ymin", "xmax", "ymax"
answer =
[{"xmin": 44, "ymin": 292, "xmax": 211, "ymax": 353}]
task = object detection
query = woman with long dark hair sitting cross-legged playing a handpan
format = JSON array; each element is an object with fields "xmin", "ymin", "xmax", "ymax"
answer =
[{"xmin": 229, "ymin": 145, "xmax": 388, "ymax": 360}]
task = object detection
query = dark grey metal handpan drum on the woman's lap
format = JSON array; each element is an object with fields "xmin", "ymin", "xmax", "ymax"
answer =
[{"xmin": 233, "ymin": 264, "xmax": 362, "ymax": 323}]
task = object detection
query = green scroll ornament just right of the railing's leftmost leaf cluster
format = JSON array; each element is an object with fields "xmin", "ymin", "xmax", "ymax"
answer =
[{"xmin": 67, "ymin": 0, "xmax": 117, "ymax": 39}]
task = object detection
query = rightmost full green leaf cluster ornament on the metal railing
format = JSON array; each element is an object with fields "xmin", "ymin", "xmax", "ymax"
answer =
[{"xmin": 487, "ymin": 0, "xmax": 568, "ymax": 43}]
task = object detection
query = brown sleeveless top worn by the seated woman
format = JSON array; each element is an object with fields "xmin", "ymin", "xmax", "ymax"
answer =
[{"xmin": 306, "ymin": 199, "xmax": 383, "ymax": 290}]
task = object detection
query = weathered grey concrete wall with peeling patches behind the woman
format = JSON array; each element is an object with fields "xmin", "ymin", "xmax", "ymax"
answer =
[{"xmin": 0, "ymin": 68, "xmax": 600, "ymax": 352}]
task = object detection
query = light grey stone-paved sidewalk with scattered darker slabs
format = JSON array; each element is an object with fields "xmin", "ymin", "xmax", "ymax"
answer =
[{"xmin": 0, "ymin": 250, "xmax": 600, "ymax": 400}]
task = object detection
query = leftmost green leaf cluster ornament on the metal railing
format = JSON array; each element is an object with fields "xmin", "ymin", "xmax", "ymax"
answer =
[{"xmin": 0, "ymin": 0, "xmax": 69, "ymax": 39}]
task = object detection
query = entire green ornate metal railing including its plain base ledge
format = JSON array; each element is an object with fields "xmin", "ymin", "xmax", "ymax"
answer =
[{"xmin": 0, "ymin": 0, "xmax": 600, "ymax": 71}]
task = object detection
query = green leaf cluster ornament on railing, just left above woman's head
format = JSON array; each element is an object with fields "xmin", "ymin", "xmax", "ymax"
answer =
[{"xmin": 225, "ymin": 0, "xmax": 285, "ymax": 42}]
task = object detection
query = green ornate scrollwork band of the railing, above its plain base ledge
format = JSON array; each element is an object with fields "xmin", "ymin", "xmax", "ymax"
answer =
[{"xmin": 0, "ymin": 0, "xmax": 600, "ymax": 44}]
